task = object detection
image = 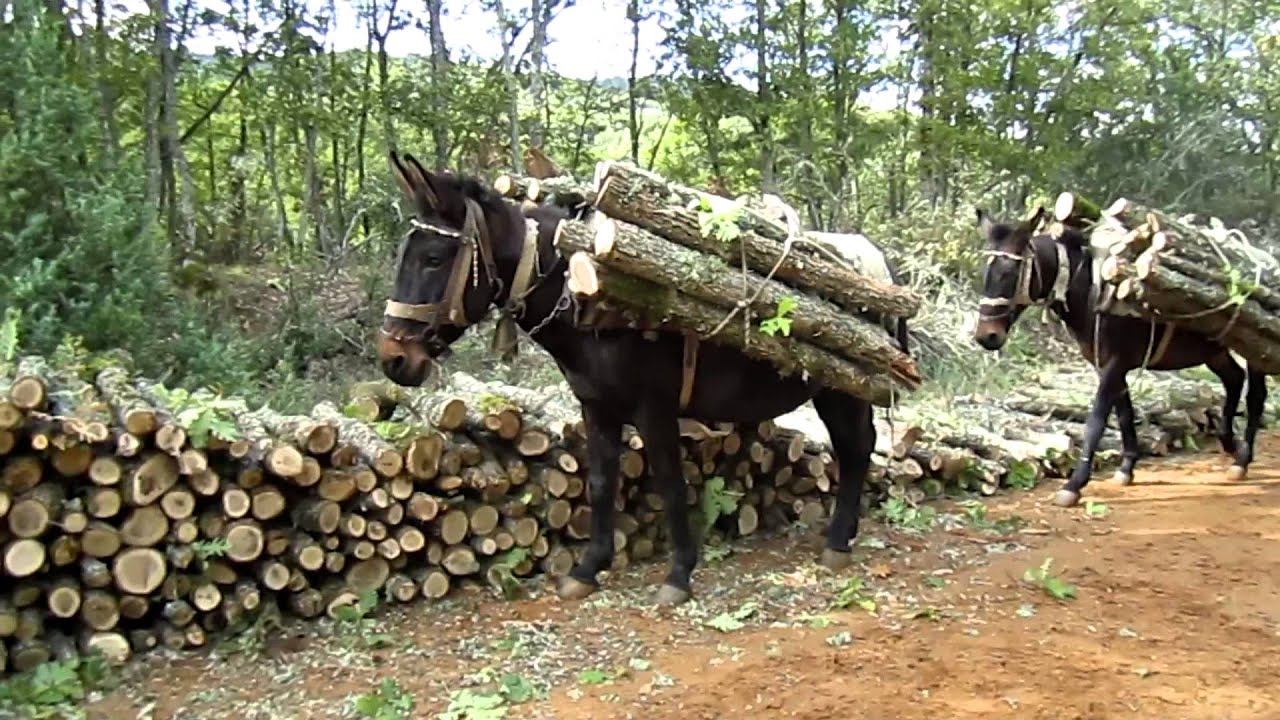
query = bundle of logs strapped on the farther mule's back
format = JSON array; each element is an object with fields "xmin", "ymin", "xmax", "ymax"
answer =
[{"xmin": 1053, "ymin": 192, "xmax": 1280, "ymax": 374}]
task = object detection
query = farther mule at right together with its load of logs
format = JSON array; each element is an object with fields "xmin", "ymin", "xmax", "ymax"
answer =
[{"xmin": 974, "ymin": 202, "xmax": 1280, "ymax": 506}]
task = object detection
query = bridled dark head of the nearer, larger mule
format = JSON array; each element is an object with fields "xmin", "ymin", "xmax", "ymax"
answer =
[{"xmin": 378, "ymin": 152, "xmax": 500, "ymax": 386}]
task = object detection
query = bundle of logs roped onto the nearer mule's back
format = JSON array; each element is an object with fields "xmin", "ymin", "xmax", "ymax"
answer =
[{"xmin": 494, "ymin": 161, "xmax": 922, "ymax": 405}]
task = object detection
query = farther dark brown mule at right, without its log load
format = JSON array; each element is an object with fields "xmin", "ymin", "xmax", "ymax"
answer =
[{"xmin": 974, "ymin": 208, "xmax": 1267, "ymax": 507}]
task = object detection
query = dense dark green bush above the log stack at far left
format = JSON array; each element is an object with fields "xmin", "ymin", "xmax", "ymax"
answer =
[{"xmin": 0, "ymin": 1, "xmax": 268, "ymax": 387}]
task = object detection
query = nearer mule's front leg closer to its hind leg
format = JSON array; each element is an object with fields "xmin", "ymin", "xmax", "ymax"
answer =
[{"xmin": 629, "ymin": 401, "xmax": 698, "ymax": 605}]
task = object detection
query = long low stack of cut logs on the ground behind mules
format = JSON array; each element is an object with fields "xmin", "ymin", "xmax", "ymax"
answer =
[{"xmin": 0, "ymin": 356, "xmax": 1219, "ymax": 670}]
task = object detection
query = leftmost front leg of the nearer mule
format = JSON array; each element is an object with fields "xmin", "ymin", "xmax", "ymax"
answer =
[{"xmin": 557, "ymin": 404, "xmax": 622, "ymax": 600}]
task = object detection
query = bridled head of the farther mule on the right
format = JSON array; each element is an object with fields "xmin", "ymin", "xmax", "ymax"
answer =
[{"xmin": 974, "ymin": 208, "xmax": 1047, "ymax": 350}]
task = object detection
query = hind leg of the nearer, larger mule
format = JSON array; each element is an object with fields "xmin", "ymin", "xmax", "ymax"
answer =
[{"xmin": 813, "ymin": 389, "xmax": 876, "ymax": 570}]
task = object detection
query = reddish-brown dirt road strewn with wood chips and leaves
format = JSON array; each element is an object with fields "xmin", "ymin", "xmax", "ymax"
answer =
[{"xmin": 91, "ymin": 433, "xmax": 1280, "ymax": 720}]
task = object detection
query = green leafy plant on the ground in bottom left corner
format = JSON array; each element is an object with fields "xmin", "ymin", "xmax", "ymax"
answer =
[{"xmin": 0, "ymin": 653, "xmax": 113, "ymax": 720}]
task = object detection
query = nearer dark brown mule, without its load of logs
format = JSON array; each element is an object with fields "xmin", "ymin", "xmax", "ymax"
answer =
[{"xmin": 378, "ymin": 154, "xmax": 905, "ymax": 603}]
